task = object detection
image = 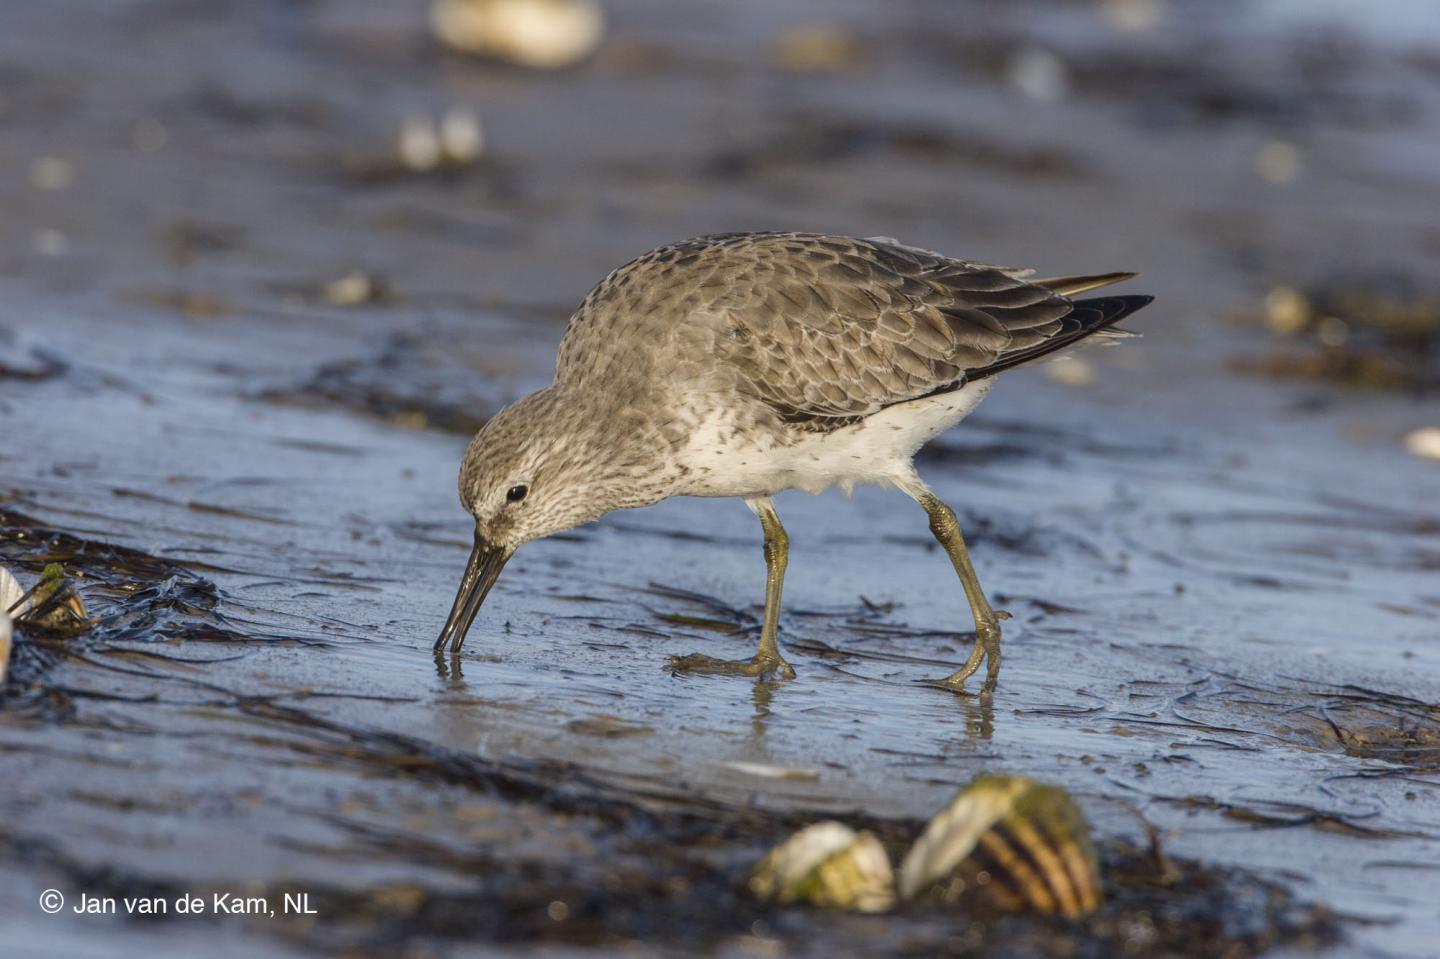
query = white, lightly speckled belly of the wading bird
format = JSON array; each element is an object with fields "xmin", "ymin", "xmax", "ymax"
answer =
[{"xmin": 681, "ymin": 380, "xmax": 992, "ymax": 497}]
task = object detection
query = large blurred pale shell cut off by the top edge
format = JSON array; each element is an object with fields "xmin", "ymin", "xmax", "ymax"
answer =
[{"xmin": 431, "ymin": 0, "xmax": 605, "ymax": 69}]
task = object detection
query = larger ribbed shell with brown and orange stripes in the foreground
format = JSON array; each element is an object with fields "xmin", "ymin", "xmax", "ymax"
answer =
[{"xmin": 900, "ymin": 775, "xmax": 1100, "ymax": 917}]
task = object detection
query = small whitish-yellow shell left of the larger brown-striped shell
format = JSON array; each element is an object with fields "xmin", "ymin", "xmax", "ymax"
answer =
[{"xmin": 750, "ymin": 822, "xmax": 894, "ymax": 913}]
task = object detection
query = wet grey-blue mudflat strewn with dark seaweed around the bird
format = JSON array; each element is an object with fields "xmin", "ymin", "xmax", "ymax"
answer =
[{"xmin": 0, "ymin": 3, "xmax": 1440, "ymax": 955}]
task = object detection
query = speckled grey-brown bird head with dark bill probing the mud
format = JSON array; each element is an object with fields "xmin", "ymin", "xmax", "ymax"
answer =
[{"xmin": 435, "ymin": 390, "xmax": 601, "ymax": 651}]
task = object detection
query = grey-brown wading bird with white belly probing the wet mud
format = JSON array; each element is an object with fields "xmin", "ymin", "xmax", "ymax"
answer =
[{"xmin": 435, "ymin": 233, "xmax": 1151, "ymax": 691}]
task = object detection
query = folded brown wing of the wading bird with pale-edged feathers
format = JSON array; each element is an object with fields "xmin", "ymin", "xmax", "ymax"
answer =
[{"xmin": 711, "ymin": 235, "xmax": 1111, "ymax": 429}]
